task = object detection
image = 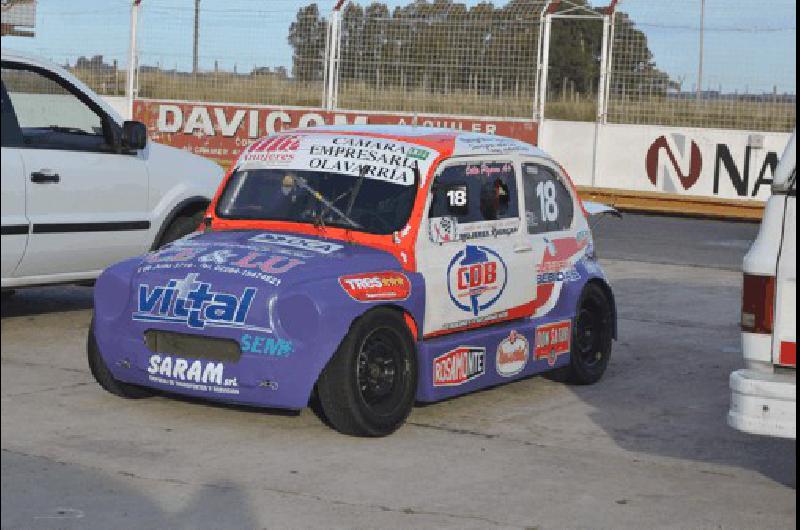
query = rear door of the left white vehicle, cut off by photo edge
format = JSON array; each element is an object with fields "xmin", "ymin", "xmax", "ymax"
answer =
[{"xmin": 0, "ymin": 79, "xmax": 30, "ymax": 278}]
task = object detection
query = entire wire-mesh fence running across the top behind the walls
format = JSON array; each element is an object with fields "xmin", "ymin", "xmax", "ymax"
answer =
[{"xmin": 3, "ymin": 0, "xmax": 796, "ymax": 131}]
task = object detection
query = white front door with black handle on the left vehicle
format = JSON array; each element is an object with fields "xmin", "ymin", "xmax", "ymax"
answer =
[{"xmin": 2, "ymin": 61, "xmax": 150, "ymax": 277}]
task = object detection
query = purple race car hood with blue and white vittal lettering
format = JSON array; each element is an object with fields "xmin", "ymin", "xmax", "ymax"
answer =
[{"xmin": 115, "ymin": 231, "xmax": 410, "ymax": 340}]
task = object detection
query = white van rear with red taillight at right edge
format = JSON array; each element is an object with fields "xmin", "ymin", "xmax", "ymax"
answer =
[{"xmin": 728, "ymin": 133, "xmax": 797, "ymax": 439}]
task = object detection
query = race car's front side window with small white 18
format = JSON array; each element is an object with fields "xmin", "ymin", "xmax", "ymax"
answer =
[{"xmin": 428, "ymin": 161, "xmax": 519, "ymax": 224}]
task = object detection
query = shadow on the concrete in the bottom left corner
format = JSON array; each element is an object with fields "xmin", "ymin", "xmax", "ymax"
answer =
[{"xmin": 2, "ymin": 450, "xmax": 261, "ymax": 529}]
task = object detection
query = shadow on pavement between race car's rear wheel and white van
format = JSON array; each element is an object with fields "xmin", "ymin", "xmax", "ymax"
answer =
[{"xmin": 572, "ymin": 279, "xmax": 797, "ymax": 487}]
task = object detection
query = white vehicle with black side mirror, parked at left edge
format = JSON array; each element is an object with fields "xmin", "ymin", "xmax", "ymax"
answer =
[{"xmin": 0, "ymin": 49, "xmax": 223, "ymax": 292}]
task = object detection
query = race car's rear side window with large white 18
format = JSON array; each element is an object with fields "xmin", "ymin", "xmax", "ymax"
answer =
[{"xmin": 522, "ymin": 164, "xmax": 575, "ymax": 234}]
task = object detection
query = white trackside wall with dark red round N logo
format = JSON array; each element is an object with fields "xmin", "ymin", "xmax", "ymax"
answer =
[{"xmin": 539, "ymin": 120, "xmax": 790, "ymax": 201}]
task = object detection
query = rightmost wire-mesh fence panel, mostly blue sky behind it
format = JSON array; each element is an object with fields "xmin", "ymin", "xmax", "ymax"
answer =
[{"xmin": 608, "ymin": 0, "xmax": 797, "ymax": 131}]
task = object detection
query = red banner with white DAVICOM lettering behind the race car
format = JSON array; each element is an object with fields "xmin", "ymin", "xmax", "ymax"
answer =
[{"xmin": 133, "ymin": 100, "xmax": 538, "ymax": 164}]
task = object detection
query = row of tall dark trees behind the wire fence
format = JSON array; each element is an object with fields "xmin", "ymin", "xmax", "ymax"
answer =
[{"xmin": 289, "ymin": 0, "xmax": 672, "ymax": 96}]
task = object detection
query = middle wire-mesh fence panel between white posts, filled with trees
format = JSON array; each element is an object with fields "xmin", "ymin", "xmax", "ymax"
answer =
[{"xmin": 338, "ymin": 0, "xmax": 545, "ymax": 117}]
